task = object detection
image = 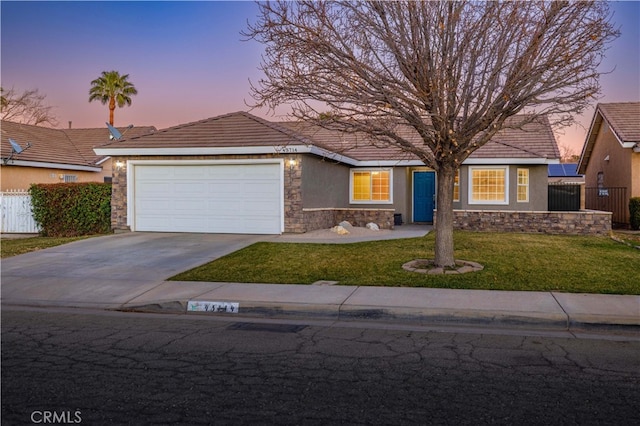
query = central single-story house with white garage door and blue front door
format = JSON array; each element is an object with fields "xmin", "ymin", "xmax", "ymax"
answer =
[{"xmin": 95, "ymin": 112, "xmax": 560, "ymax": 234}]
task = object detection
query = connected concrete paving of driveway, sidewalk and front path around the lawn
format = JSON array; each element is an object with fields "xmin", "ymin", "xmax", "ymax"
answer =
[{"xmin": 2, "ymin": 227, "xmax": 640, "ymax": 335}]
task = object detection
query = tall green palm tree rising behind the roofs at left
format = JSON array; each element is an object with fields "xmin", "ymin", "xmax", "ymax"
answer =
[{"xmin": 89, "ymin": 71, "xmax": 138, "ymax": 126}]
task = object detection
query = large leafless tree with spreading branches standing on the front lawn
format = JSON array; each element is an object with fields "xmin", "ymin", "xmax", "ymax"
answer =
[{"xmin": 244, "ymin": 1, "xmax": 618, "ymax": 266}]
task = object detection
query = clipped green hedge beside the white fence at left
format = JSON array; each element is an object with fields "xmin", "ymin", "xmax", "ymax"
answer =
[{"xmin": 29, "ymin": 183, "xmax": 111, "ymax": 237}]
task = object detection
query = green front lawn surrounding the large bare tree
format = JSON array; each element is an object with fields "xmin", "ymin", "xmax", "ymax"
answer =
[{"xmin": 172, "ymin": 232, "xmax": 640, "ymax": 294}]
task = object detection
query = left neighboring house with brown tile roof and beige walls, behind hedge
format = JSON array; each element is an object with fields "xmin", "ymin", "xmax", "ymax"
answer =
[{"xmin": 0, "ymin": 121, "xmax": 155, "ymax": 191}]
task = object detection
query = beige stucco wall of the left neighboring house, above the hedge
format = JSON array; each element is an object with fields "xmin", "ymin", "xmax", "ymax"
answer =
[{"xmin": 0, "ymin": 159, "xmax": 111, "ymax": 191}]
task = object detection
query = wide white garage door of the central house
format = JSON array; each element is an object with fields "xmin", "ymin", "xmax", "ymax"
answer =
[{"xmin": 132, "ymin": 163, "xmax": 283, "ymax": 234}]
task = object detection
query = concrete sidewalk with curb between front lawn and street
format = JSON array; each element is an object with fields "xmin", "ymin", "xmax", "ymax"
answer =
[{"xmin": 118, "ymin": 281, "xmax": 640, "ymax": 333}]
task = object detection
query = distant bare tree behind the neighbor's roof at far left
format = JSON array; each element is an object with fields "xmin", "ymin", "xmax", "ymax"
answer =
[{"xmin": 0, "ymin": 87, "xmax": 58, "ymax": 127}]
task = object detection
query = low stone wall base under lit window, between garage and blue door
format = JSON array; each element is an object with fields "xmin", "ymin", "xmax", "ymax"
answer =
[{"xmin": 302, "ymin": 208, "xmax": 395, "ymax": 232}]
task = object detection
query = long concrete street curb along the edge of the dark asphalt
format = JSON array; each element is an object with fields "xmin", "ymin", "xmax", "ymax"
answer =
[{"xmin": 8, "ymin": 300, "xmax": 640, "ymax": 335}]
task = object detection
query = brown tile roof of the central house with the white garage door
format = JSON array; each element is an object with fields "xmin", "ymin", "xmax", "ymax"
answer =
[{"xmin": 100, "ymin": 112, "xmax": 560, "ymax": 161}]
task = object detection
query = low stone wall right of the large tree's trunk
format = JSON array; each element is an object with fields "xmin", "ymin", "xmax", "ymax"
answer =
[{"xmin": 442, "ymin": 210, "xmax": 611, "ymax": 235}]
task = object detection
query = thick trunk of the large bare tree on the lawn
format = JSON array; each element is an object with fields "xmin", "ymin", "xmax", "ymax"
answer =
[{"xmin": 434, "ymin": 166, "xmax": 456, "ymax": 267}]
